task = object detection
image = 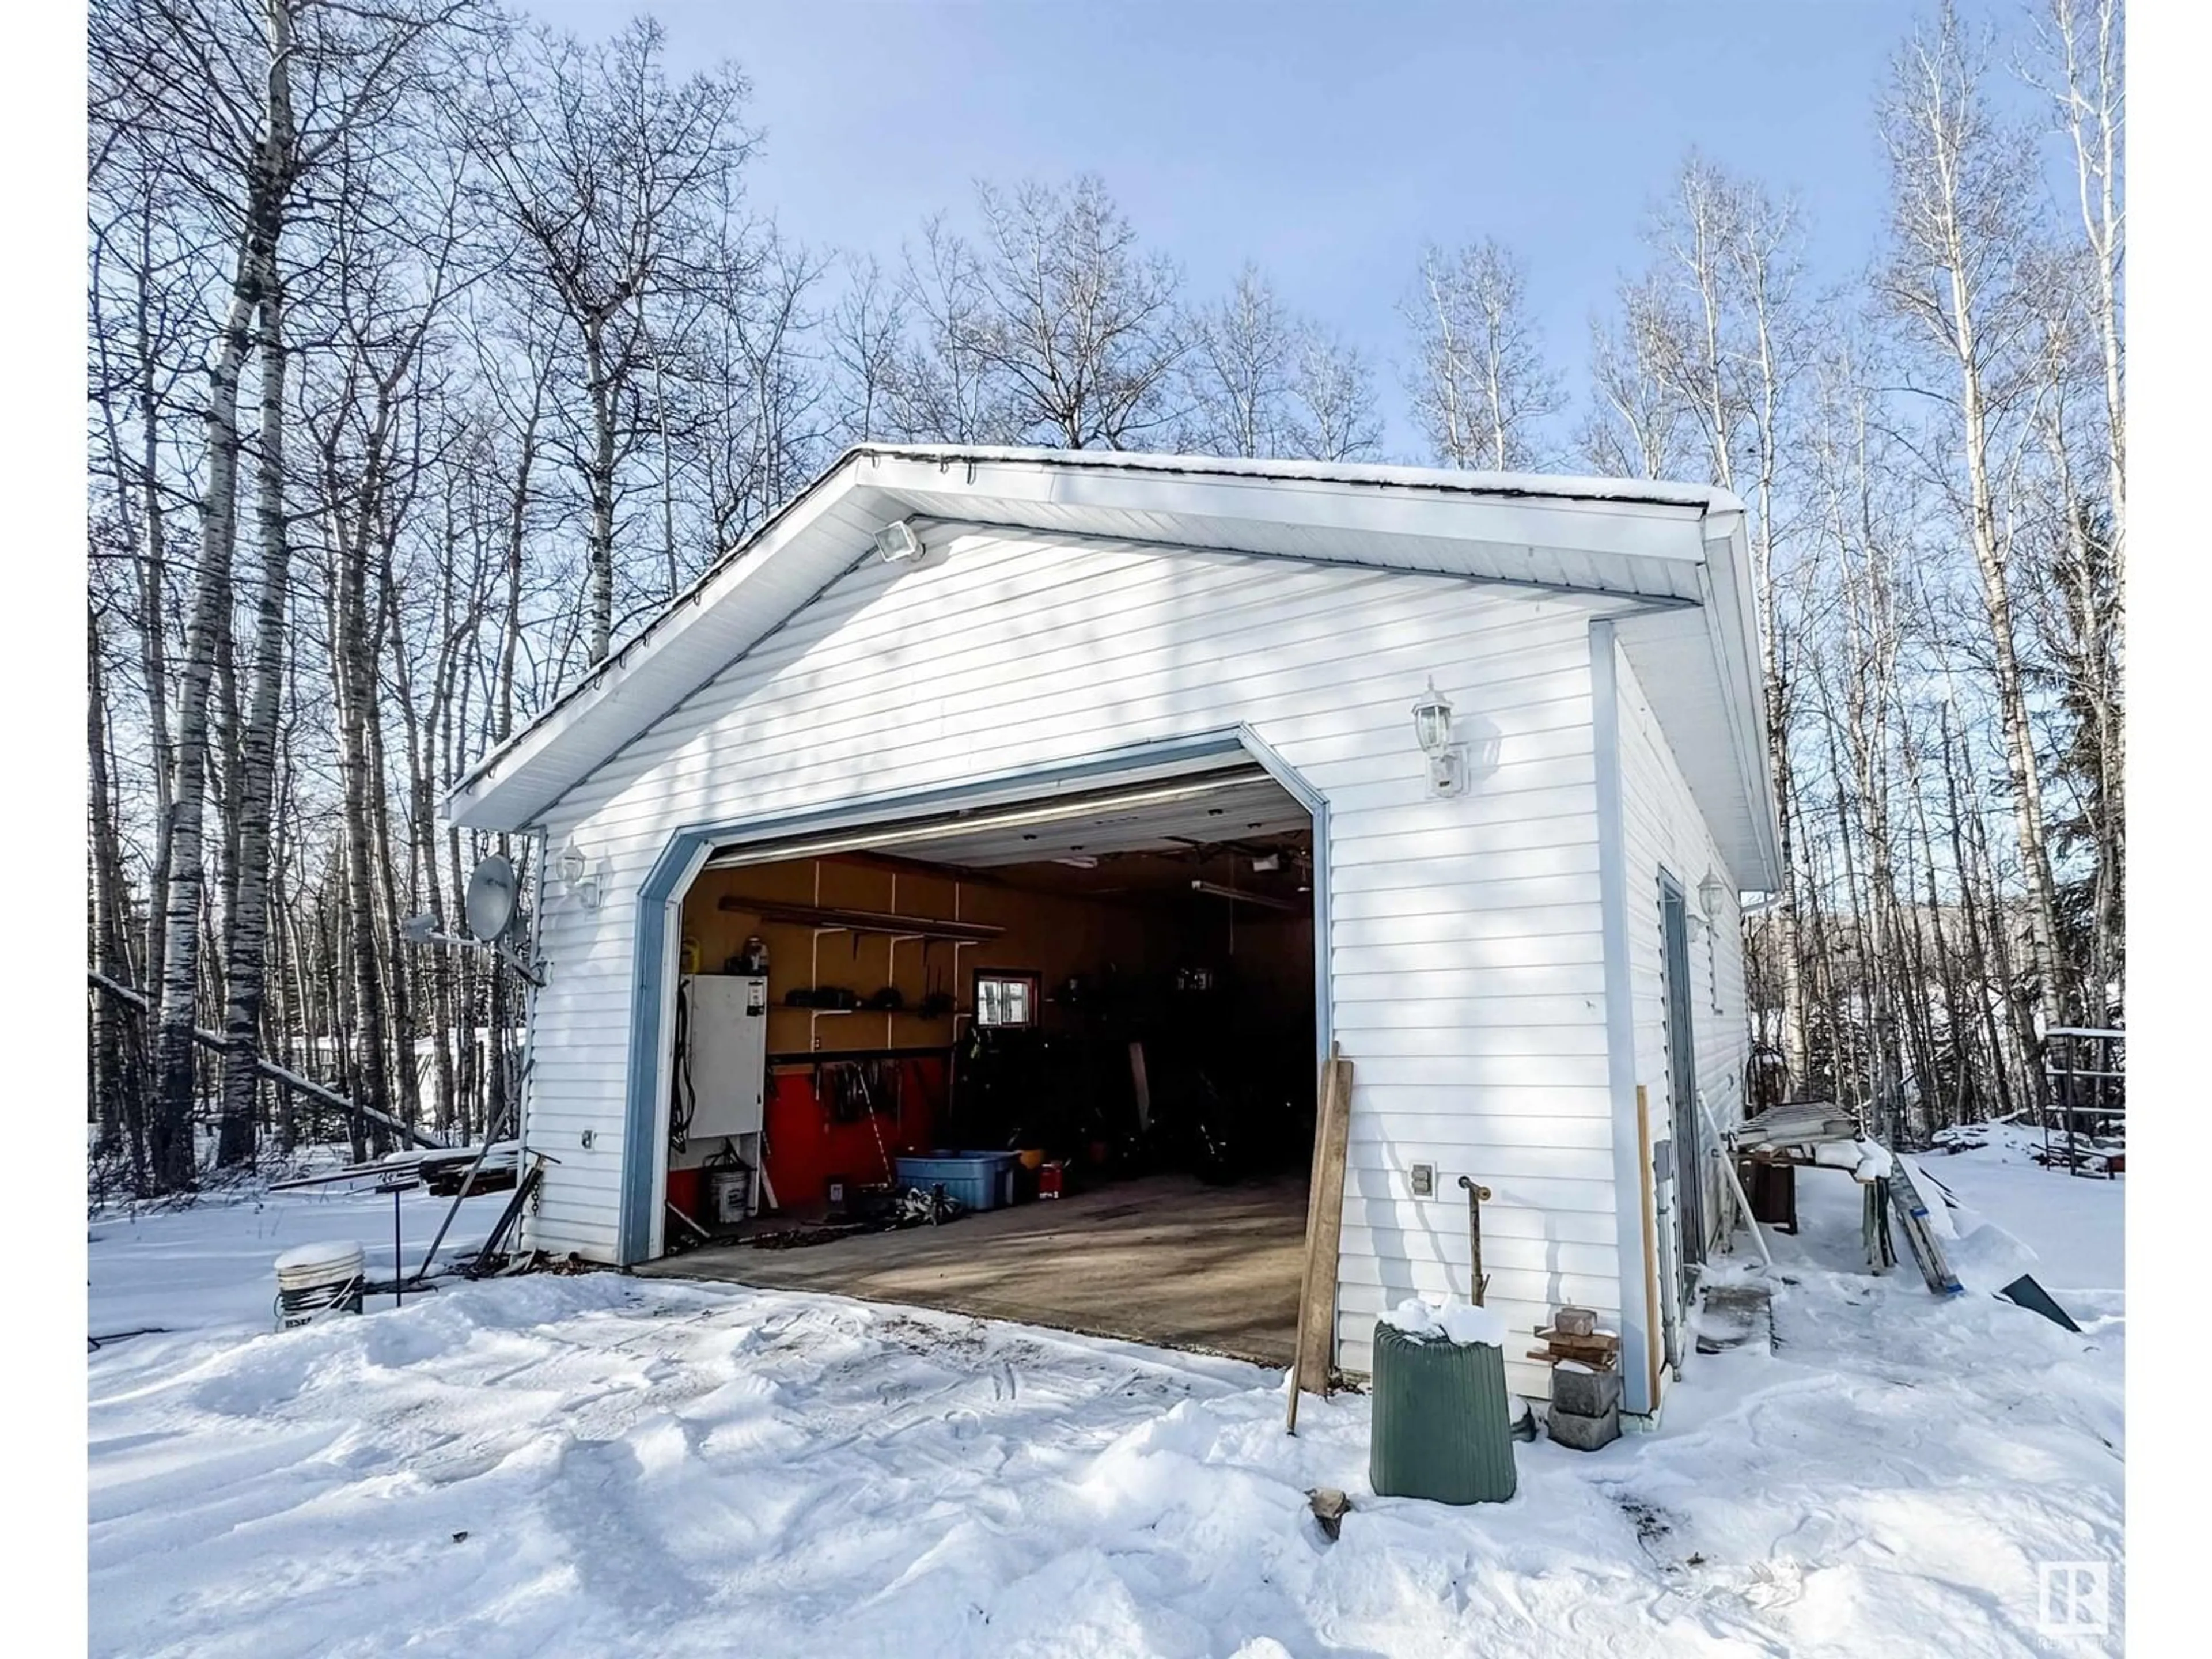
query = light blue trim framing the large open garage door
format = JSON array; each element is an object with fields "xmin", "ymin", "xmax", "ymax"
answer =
[{"xmin": 615, "ymin": 726, "xmax": 1334, "ymax": 1267}]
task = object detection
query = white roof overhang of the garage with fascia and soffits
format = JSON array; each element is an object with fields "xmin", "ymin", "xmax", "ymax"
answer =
[{"xmin": 447, "ymin": 445, "xmax": 1778, "ymax": 887}]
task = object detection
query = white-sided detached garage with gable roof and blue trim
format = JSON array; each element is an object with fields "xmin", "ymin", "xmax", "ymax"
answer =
[{"xmin": 447, "ymin": 445, "xmax": 1777, "ymax": 1411}]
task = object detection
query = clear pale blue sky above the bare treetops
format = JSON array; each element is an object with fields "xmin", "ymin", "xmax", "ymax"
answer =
[{"xmin": 531, "ymin": 0, "xmax": 2017, "ymax": 449}]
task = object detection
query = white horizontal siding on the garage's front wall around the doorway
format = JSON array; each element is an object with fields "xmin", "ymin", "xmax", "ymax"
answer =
[{"xmin": 529, "ymin": 533, "xmax": 1619, "ymax": 1391}]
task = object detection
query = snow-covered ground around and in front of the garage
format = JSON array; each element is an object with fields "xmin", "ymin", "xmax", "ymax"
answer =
[{"xmin": 89, "ymin": 1143, "xmax": 2126, "ymax": 1659}]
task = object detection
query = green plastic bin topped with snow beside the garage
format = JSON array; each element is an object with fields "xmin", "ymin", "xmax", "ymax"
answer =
[{"xmin": 1367, "ymin": 1296, "xmax": 1515, "ymax": 1504}]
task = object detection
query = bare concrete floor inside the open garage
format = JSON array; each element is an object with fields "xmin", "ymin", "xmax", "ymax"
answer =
[{"xmin": 637, "ymin": 1175, "xmax": 1305, "ymax": 1367}]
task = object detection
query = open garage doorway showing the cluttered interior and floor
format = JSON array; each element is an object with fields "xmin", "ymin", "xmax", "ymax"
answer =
[{"xmin": 643, "ymin": 766, "xmax": 1316, "ymax": 1365}]
